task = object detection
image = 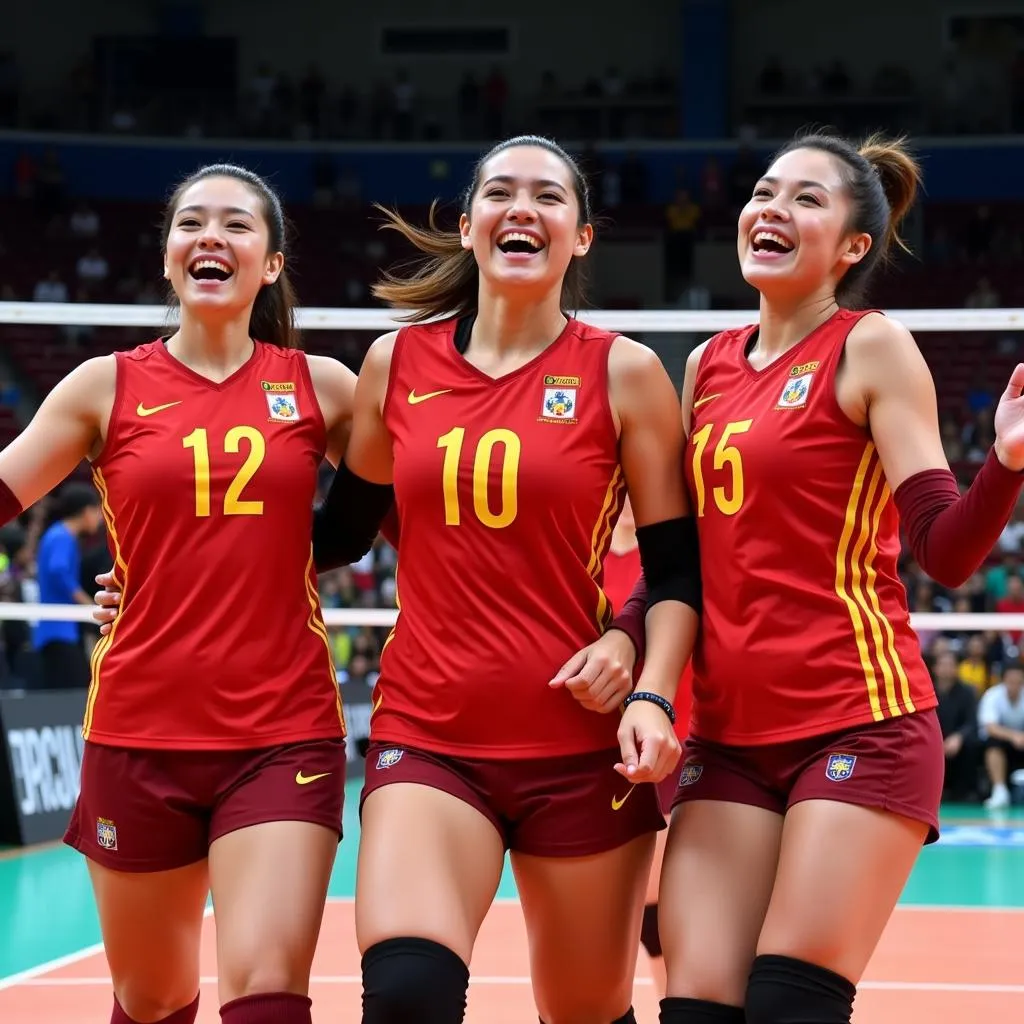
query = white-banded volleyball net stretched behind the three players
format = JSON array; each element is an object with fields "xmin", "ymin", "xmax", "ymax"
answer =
[{"xmin": 0, "ymin": 302, "xmax": 1024, "ymax": 635}]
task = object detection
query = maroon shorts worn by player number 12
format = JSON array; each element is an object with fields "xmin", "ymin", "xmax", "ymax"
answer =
[{"xmin": 65, "ymin": 739, "xmax": 345, "ymax": 871}]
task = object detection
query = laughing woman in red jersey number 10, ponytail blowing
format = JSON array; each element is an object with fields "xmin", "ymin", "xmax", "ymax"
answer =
[{"xmin": 319, "ymin": 136, "xmax": 698, "ymax": 1024}]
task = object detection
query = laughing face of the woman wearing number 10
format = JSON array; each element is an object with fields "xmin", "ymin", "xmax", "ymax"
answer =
[{"xmin": 459, "ymin": 145, "xmax": 594, "ymax": 301}]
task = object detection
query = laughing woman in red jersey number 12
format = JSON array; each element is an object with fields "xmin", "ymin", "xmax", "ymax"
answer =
[{"xmin": 0, "ymin": 165, "xmax": 368, "ymax": 1024}]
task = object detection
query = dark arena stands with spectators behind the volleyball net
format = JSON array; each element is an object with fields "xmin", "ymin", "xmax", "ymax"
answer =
[{"xmin": 0, "ymin": 0, "xmax": 1024, "ymax": 843}]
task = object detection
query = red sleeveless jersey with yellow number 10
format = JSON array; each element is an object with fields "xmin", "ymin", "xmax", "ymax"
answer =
[{"xmin": 371, "ymin": 319, "xmax": 625, "ymax": 759}]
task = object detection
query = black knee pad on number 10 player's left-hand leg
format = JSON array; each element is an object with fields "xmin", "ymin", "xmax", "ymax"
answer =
[{"xmin": 362, "ymin": 938, "xmax": 469, "ymax": 1024}]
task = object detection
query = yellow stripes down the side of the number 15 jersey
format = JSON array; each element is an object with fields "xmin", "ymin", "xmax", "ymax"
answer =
[{"xmin": 836, "ymin": 441, "xmax": 913, "ymax": 721}]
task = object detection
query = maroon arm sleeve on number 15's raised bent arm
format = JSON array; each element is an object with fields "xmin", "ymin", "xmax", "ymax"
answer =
[{"xmin": 893, "ymin": 449, "xmax": 1024, "ymax": 587}]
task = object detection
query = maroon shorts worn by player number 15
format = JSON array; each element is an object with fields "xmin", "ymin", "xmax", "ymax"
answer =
[{"xmin": 673, "ymin": 710, "xmax": 945, "ymax": 843}]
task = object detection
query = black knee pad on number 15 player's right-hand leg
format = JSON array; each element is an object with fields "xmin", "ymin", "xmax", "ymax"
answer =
[{"xmin": 745, "ymin": 954, "xmax": 857, "ymax": 1024}]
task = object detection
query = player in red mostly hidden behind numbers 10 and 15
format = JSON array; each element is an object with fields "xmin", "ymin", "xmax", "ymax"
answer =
[{"xmin": 589, "ymin": 498, "xmax": 692, "ymax": 995}]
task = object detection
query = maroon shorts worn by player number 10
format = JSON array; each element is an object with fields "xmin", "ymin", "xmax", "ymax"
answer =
[{"xmin": 359, "ymin": 742, "xmax": 665, "ymax": 857}]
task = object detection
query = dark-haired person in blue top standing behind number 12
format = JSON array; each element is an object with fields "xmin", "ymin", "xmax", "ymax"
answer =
[{"xmin": 32, "ymin": 483, "xmax": 102, "ymax": 690}]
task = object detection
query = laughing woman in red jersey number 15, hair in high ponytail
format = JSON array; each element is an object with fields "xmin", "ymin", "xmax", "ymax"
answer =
[{"xmin": 581, "ymin": 135, "xmax": 1024, "ymax": 1024}]
